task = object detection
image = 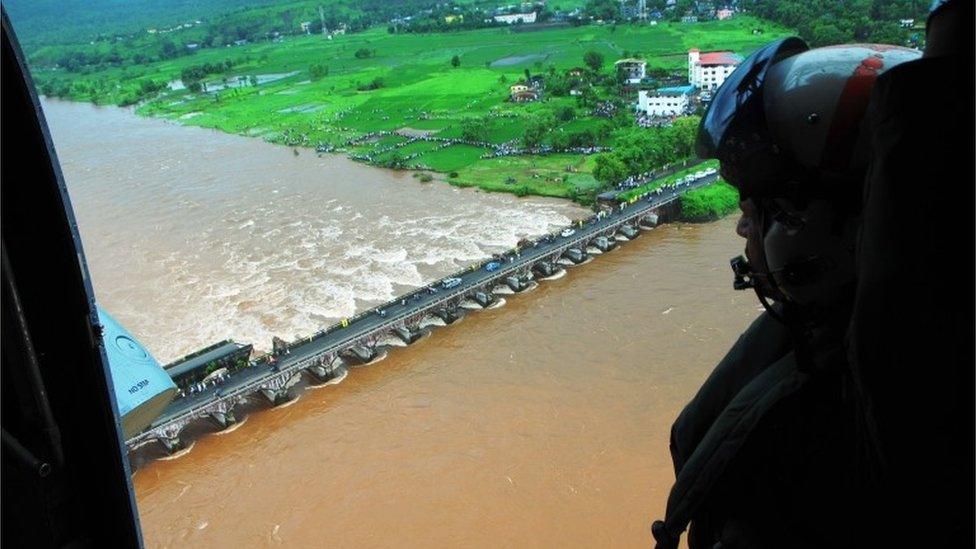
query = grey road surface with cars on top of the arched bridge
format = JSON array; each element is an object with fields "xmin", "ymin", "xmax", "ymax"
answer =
[{"xmin": 126, "ymin": 175, "xmax": 716, "ymax": 450}]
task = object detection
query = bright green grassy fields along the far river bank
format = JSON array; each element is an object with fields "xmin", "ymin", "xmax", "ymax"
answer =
[{"xmin": 35, "ymin": 16, "xmax": 787, "ymax": 201}]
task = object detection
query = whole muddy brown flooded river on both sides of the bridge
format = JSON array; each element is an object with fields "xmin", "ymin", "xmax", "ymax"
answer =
[{"xmin": 47, "ymin": 97, "xmax": 758, "ymax": 547}]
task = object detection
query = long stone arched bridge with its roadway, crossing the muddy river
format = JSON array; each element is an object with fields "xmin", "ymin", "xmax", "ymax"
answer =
[{"xmin": 126, "ymin": 175, "xmax": 717, "ymax": 452}]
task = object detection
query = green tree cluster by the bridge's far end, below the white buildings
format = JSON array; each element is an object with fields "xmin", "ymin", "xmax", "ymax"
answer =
[{"xmin": 593, "ymin": 116, "xmax": 701, "ymax": 185}]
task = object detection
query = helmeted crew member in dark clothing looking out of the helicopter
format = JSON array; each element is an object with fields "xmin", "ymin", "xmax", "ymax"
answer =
[{"xmin": 651, "ymin": 38, "xmax": 918, "ymax": 549}]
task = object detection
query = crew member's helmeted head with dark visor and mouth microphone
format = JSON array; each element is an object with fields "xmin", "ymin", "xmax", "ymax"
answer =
[{"xmin": 696, "ymin": 38, "xmax": 920, "ymax": 306}]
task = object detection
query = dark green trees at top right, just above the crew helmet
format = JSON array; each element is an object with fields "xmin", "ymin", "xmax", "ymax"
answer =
[{"xmin": 739, "ymin": 0, "xmax": 928, "ymax": 46}]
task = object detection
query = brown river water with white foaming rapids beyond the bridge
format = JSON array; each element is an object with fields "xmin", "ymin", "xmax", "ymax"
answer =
[{"xmin": 43, "ymin": 101, "xmax": 589, "ymax": 362}]
